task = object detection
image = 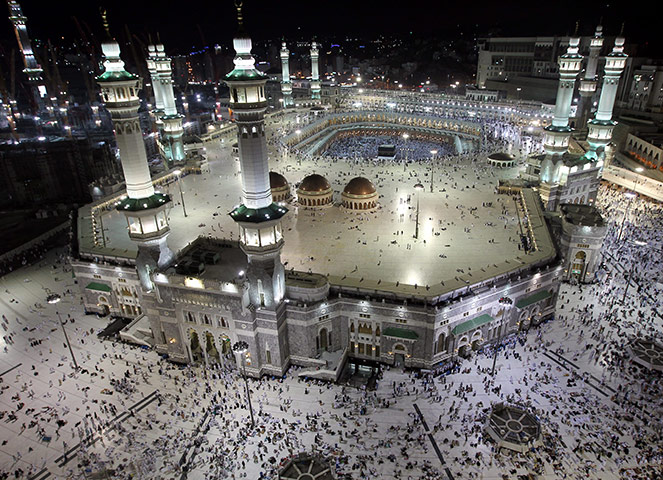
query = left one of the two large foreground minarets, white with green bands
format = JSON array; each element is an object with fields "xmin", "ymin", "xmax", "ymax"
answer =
[{"xmin": 97, "ymin": 12, "xmax": 173, "ymax": 290}]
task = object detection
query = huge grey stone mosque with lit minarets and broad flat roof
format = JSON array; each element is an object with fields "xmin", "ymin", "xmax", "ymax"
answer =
[{"xmin": 72, "ymin": 8, "xmax": 623, "ymax": 381}]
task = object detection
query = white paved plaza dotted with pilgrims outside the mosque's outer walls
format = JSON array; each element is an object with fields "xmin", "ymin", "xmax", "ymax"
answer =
[{"xmin": 0, "ymin": 107, "xmax": 663, "ymax": 480}]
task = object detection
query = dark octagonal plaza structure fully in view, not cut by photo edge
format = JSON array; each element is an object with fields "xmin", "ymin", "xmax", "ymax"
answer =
[{"xmin": 486, "ymin": 403, "xmax": 543, "ymax": 452}]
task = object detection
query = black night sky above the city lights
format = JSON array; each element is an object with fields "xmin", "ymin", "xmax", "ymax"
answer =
[{"xmin": 0, "ymin": 0, "xmax": 662, "ymax": 54}]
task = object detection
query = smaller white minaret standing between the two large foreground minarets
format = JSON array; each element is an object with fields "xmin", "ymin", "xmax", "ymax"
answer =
[{"xmin": 147, "ymin": 43, "xmax": 185, "ymax": 166}]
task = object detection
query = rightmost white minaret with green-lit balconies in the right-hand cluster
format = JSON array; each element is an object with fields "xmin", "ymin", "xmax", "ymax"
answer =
[{"xmin": 586, "ymin": 33, "xmax": 628, "ymax": 160}]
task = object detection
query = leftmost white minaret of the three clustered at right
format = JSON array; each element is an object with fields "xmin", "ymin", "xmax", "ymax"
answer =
[{"xmin": 541, "ymin": 36, "xmax": 582, "ymax": 184}]
